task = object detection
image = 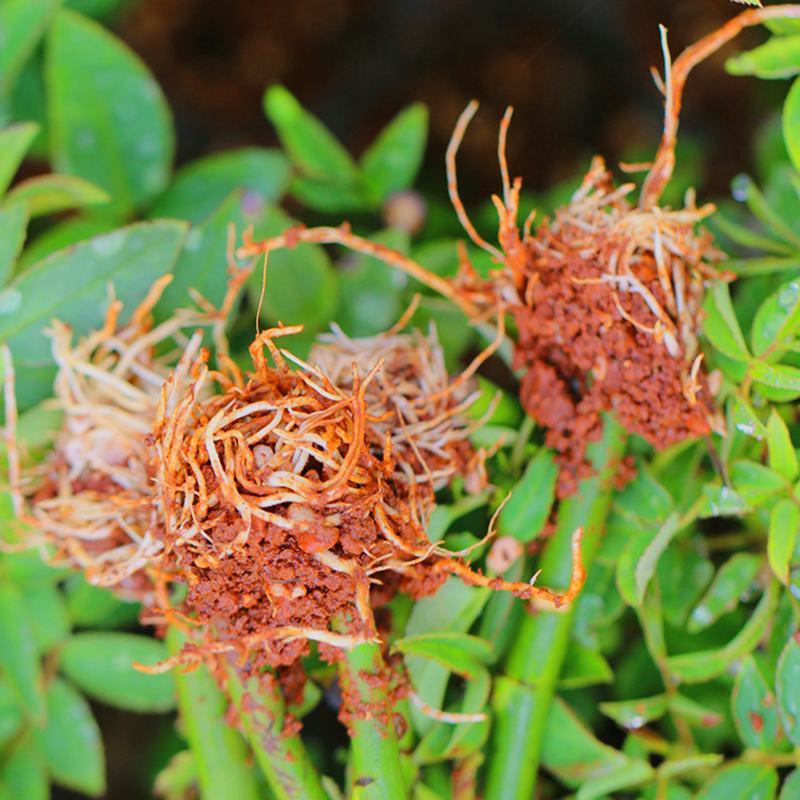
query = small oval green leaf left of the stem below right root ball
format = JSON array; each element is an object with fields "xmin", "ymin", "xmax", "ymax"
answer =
[{"xmin": 497, "ymin": 447, "xmax": 558, "ymax": 542}]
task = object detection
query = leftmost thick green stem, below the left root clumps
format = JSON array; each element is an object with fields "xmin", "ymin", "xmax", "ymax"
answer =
[{"xmin": 167, "ymin": 628, "xmax": 259, "ymax": 800}]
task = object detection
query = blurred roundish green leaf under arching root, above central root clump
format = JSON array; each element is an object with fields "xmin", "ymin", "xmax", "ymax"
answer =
[{"xmin": 249, "ymin": 207, "xmax": 339, "ymax": 333}]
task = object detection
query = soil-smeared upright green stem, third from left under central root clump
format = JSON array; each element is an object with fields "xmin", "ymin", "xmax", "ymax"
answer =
[{"xmin": 339, "ymin": 642, "xmax": 408, "ymax": 800}]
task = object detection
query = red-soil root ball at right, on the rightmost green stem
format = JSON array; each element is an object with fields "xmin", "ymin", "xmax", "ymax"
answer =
[{"xmin": 510, "ymin": 159, "xmax": 720, "ymax": 496}]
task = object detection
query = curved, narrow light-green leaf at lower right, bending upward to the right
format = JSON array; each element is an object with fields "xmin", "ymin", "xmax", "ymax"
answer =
[{"xmin": 667, "ymin": 581, "xmax": 778, "ymax": 683}]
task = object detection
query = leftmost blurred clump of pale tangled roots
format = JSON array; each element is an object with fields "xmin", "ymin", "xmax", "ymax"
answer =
[{"xmin": 20, "ymin": 276, "xmax": 205, "ymax": 596}]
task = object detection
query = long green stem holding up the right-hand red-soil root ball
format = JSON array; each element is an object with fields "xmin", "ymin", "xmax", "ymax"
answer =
[{"xmin": 484, "ymin": 417, "xmax": 625, "ymax": 800}]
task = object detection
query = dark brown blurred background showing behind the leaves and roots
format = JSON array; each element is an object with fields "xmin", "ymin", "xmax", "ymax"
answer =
[{"xmin": 55, "ymin": 0, "xmax": 786, "ymax": 800}]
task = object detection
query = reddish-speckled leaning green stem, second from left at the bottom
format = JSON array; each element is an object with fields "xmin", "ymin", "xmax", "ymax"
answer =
[{"xmin": 228, "ymin": 664, "xmax": 328, "ymax": 800}]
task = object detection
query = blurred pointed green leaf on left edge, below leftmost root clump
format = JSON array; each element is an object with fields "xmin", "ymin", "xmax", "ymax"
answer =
[{"xmin": 0, "ymin": 580, "xmax": 45, "ymax": 722}]
